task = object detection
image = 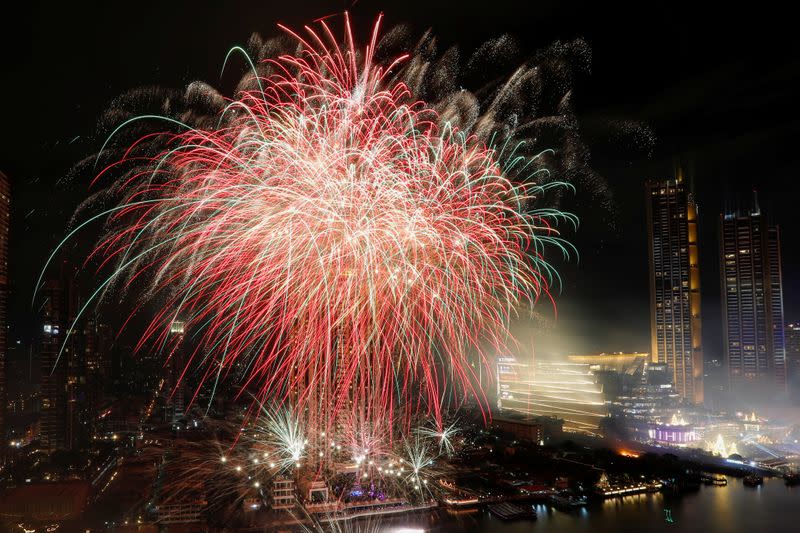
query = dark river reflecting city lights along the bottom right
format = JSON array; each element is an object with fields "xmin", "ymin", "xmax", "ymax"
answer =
[{"xmin": 386, "ymin": 477, "xmax": 800, "ymax": 533}]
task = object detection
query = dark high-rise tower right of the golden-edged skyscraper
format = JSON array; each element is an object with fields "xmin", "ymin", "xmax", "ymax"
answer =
[{"xmin": 720, "ymin": 200, "xmax": 786, "ymax": 398}]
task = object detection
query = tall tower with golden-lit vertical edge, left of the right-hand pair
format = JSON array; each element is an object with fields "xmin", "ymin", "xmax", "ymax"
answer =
[{"xmin": 646, "ymin": 176, "xmax": 703, "ymax": 403}]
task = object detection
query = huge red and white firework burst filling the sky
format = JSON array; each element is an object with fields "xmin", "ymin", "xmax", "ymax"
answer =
[{"xmin": 43, "ymin": 13, "xmax": 576, "ymax": 436}]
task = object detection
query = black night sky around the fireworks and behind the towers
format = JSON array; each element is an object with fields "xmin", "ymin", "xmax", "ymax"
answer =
[{"xmin": 0, "ymin": 0, "xmax": 800, "ymax": 357}]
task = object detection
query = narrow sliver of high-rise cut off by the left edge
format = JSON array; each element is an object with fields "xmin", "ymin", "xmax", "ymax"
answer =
[{"xmin": 0, "ymin": 172, "xmax": 11, "ymax": 444}]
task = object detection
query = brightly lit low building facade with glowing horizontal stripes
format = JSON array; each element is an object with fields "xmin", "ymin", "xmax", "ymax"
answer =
[{"xmin": 497, "ymin": 357, "xmax": 608, "ymax": 435}]
